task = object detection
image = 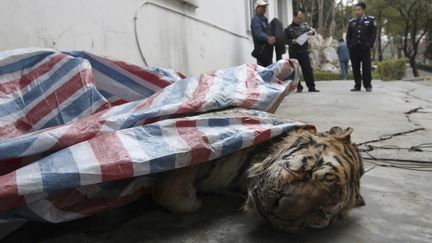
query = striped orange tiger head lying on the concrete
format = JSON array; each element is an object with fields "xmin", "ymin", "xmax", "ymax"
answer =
[{"xmin": 245, "ymin": 127, "xmax": 365, "ymax": 231}]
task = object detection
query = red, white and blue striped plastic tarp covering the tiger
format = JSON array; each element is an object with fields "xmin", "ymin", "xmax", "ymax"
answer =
[{"xmin": 0, "ymin": 49, "xmax": 306, "ymax": 222}]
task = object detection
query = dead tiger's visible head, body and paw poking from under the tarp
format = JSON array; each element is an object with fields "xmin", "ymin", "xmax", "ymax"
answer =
[{"xmin": 153, "ymin": 127, "xmax": 365, "ymax": 231}]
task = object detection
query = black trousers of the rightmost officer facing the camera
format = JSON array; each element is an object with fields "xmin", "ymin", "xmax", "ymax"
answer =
[{"xmin": 350, "ymin": 46, "xmax": 372, "ymax": 89}]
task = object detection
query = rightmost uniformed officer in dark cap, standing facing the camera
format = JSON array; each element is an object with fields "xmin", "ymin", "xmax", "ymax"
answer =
[{"xmin": 346, "ymin": 2, "xmax": 376, "ymax": 92}]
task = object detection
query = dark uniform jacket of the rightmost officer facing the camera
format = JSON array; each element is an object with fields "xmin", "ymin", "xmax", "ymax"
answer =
[{"xmin": 346, "ymin": 15, "xmax": 376, "ymax": 50}]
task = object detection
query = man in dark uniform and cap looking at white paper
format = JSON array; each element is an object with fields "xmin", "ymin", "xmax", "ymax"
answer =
[{"xmin": 285, "ymin": 10, "xmax": 319, "ymax": 92}]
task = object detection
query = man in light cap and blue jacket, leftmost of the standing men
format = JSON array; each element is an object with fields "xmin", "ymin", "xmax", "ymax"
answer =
[{"xmin": 251, "ymin": 0, "xmax": 276, "ymax": 67}]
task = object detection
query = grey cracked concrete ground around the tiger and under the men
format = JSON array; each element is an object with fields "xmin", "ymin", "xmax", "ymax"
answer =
[{"xmin": 3, "ymin": 81, "xmax": 432, "ymax": 243}]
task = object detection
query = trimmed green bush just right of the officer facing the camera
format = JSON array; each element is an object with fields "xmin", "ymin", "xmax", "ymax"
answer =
[{"xmin": 378, "ymin": 59, "xmax": 406, "ymax": 81}]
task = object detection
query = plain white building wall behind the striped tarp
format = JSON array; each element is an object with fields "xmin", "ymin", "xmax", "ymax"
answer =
[{"xmin": 0, "ymin": 0, "xmax": 291, "ymax": 75}]
